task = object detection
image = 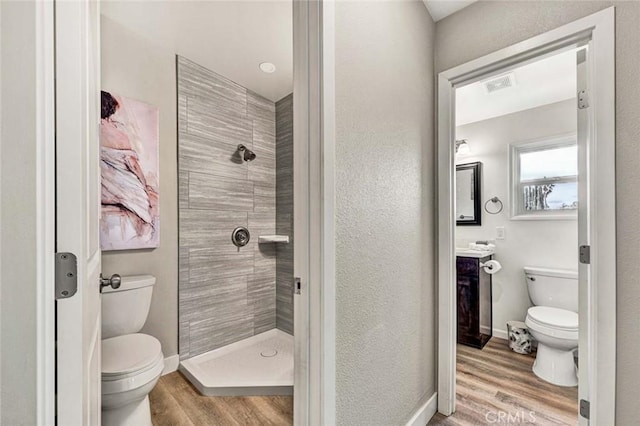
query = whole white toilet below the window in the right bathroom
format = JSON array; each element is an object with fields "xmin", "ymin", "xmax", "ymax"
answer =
[{"xmin": 524, "ymin": 267, "xmax": 578, "ymax": 386}]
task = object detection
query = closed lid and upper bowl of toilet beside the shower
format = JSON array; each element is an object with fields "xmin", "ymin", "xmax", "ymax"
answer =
[{"xmin": 102, "ymin": 333, "xmax": 164, "ymax": 395}]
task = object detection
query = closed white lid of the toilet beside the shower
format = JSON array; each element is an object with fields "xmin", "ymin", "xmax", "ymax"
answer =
[{"xmin": 102, "ymin": 333, "xmax": 162, "ymax": 376}]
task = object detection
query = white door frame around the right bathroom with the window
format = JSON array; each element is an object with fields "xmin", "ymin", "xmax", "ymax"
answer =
[{"xmin": 437, "ymin": 7, "xmax": 616, "ymax": 425}]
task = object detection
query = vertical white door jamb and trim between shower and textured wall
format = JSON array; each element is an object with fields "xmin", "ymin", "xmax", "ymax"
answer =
[{"xmin": 293, "ymin": 0, "xmax": 335, "ymax": 425}]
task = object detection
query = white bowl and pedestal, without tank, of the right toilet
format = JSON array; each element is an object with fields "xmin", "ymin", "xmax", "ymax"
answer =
[{"xmin": 525, "ymin": 306, "xmax": 578, "ymax": 386}]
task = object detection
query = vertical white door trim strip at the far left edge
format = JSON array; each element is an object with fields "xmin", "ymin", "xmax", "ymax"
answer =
[{"xmin": 35, "ymin": 1, "xmax": 56, "ymax": 425}]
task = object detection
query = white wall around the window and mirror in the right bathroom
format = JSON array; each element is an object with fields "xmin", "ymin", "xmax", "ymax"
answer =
[{"xmin": 456, "ymin": 99, "xmax": 578, "ymax": 338}]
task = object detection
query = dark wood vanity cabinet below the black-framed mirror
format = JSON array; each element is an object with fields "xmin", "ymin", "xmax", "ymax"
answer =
[{"xmin": 456, "ymin": 256, "xmax": 493, "ymax": 349}]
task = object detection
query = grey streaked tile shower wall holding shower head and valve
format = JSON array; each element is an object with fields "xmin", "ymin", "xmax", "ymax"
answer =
[{"xmin": 177, "ymin": 57, "xmax": 276, "ymax": 359}]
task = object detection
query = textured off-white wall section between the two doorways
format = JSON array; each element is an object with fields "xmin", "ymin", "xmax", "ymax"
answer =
[{"xmin": 335, "ymin": 1, "xmax": 436, "ymax": 425}]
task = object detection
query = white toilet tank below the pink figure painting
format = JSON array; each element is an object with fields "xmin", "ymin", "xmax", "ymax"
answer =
[{"xmin": 102, "ymin": 275, "xmax": 156, "ymax": 339}]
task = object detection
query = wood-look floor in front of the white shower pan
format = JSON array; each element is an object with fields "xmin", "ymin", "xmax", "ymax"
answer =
[{"xmin": 149, "ymin": 372, "xmax": 293, "ymax": 426}]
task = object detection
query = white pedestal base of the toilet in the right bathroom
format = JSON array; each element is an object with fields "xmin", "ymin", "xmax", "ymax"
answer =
[{"xmin": 533, "ymin": 342, "xmax": 578, "ymax": 386}]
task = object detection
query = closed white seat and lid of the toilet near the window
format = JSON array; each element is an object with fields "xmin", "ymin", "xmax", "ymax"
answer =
[{"xmin": 525, "ymin": 306, "xmax": 578, "ymax": 339}]
